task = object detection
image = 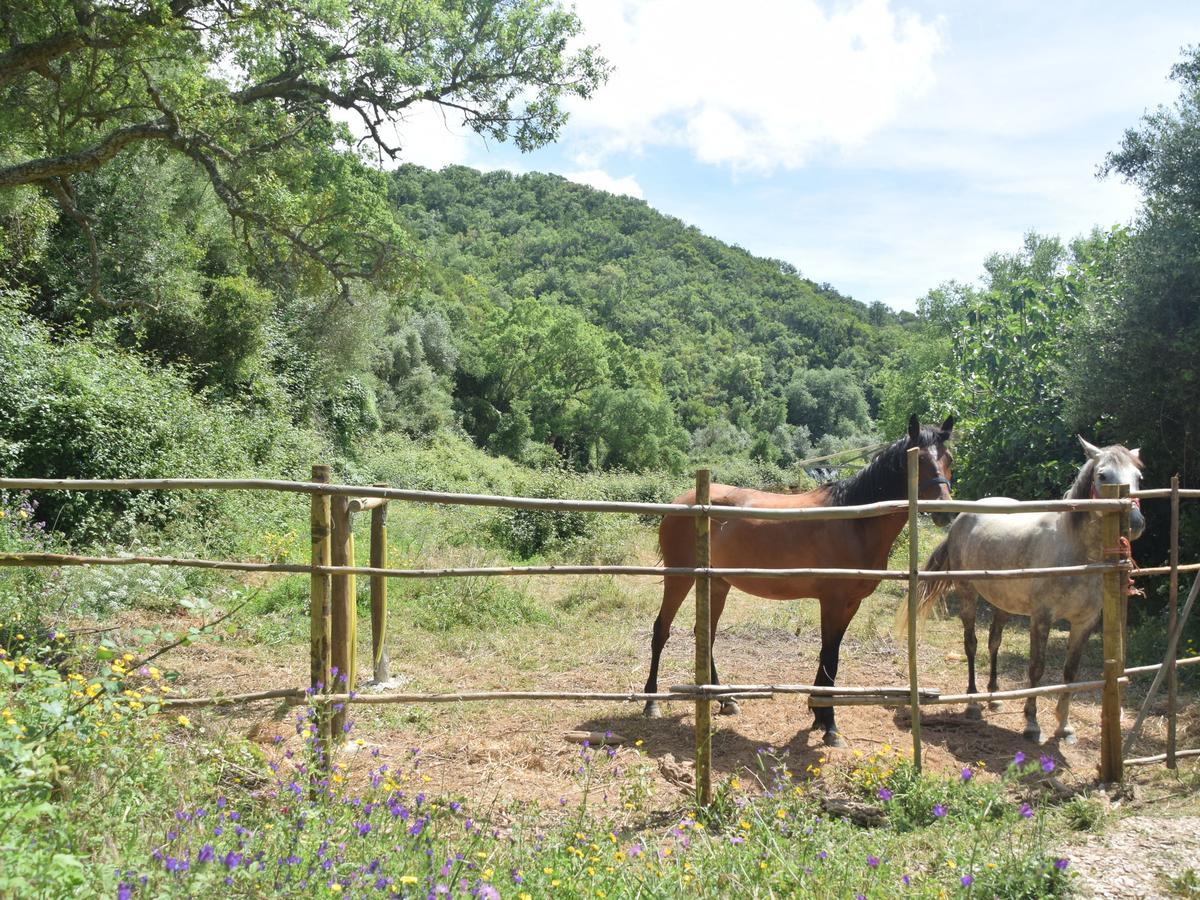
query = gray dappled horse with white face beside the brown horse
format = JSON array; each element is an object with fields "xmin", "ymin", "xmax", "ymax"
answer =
[{"xmin": 918, "ymin": 437, "xmax": 1146, "ymax": 744}]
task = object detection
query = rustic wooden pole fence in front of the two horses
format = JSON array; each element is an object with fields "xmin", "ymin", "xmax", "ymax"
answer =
[{"xmin": 0, "ymin": 465, "xmax": 1200, "ymax": 803}]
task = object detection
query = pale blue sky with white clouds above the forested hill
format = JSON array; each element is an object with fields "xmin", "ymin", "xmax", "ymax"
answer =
[{"xmin": 400, "ymin": 0, "xmax": 1200, "ymax": 308}]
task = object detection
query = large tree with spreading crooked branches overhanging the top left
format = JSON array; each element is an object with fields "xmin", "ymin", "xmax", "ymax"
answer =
[{"xmin": 0, "ymin": 0, "xmax": 606, "ymax": 303}]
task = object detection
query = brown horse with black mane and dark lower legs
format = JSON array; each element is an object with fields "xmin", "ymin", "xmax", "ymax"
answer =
[{"xmin": 646, "ymin": 415, "xmax": 954, "ymax": 746}]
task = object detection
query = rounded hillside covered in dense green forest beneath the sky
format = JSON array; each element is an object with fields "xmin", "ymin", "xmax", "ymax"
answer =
[{"xmin": 390, "ymin": 166, "xmax": 895, "ymax": 467}]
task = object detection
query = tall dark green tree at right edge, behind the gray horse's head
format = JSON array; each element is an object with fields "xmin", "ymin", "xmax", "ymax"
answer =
[{"xmin": 1069, "ymin": 47, "xmax": 1200, "ymax": 485}]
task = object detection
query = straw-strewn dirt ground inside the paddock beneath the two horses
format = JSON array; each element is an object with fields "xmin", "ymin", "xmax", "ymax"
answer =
[{"xmin": 157, "ymin": 600, "xmax": 1187, "ymax": 808}]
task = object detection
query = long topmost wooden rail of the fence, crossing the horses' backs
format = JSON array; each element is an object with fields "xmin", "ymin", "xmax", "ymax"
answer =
[{"xmin": 0, "ymin": 478, "xmax": 1129, "ymax": 521}]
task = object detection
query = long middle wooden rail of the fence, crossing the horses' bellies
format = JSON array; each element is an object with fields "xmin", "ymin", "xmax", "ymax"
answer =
[{"xmin": 0, "ymin": 553, "xmax": 1126, "ymax": 581}]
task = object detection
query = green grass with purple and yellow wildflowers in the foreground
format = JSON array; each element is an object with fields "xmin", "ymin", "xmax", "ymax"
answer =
[{"xmin": 0, "ymin": 628, "xmax": 1069, "ymax": 898}]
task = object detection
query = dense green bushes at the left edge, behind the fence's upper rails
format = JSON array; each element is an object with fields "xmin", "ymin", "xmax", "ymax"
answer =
[{"xmin": 0, "ymin": 293, "xmax": 313, "ymax": 539}]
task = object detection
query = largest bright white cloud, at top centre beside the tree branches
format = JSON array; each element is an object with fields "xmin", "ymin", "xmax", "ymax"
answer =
[{"xmin": 571, "ymin": 0, "xmax": 941, "ymax": 172}]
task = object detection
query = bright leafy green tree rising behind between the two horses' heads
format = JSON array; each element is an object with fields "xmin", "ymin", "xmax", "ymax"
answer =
[{"xmin": 883, "ymin": 234, "xmax": 1091, "ymax": 499}]
